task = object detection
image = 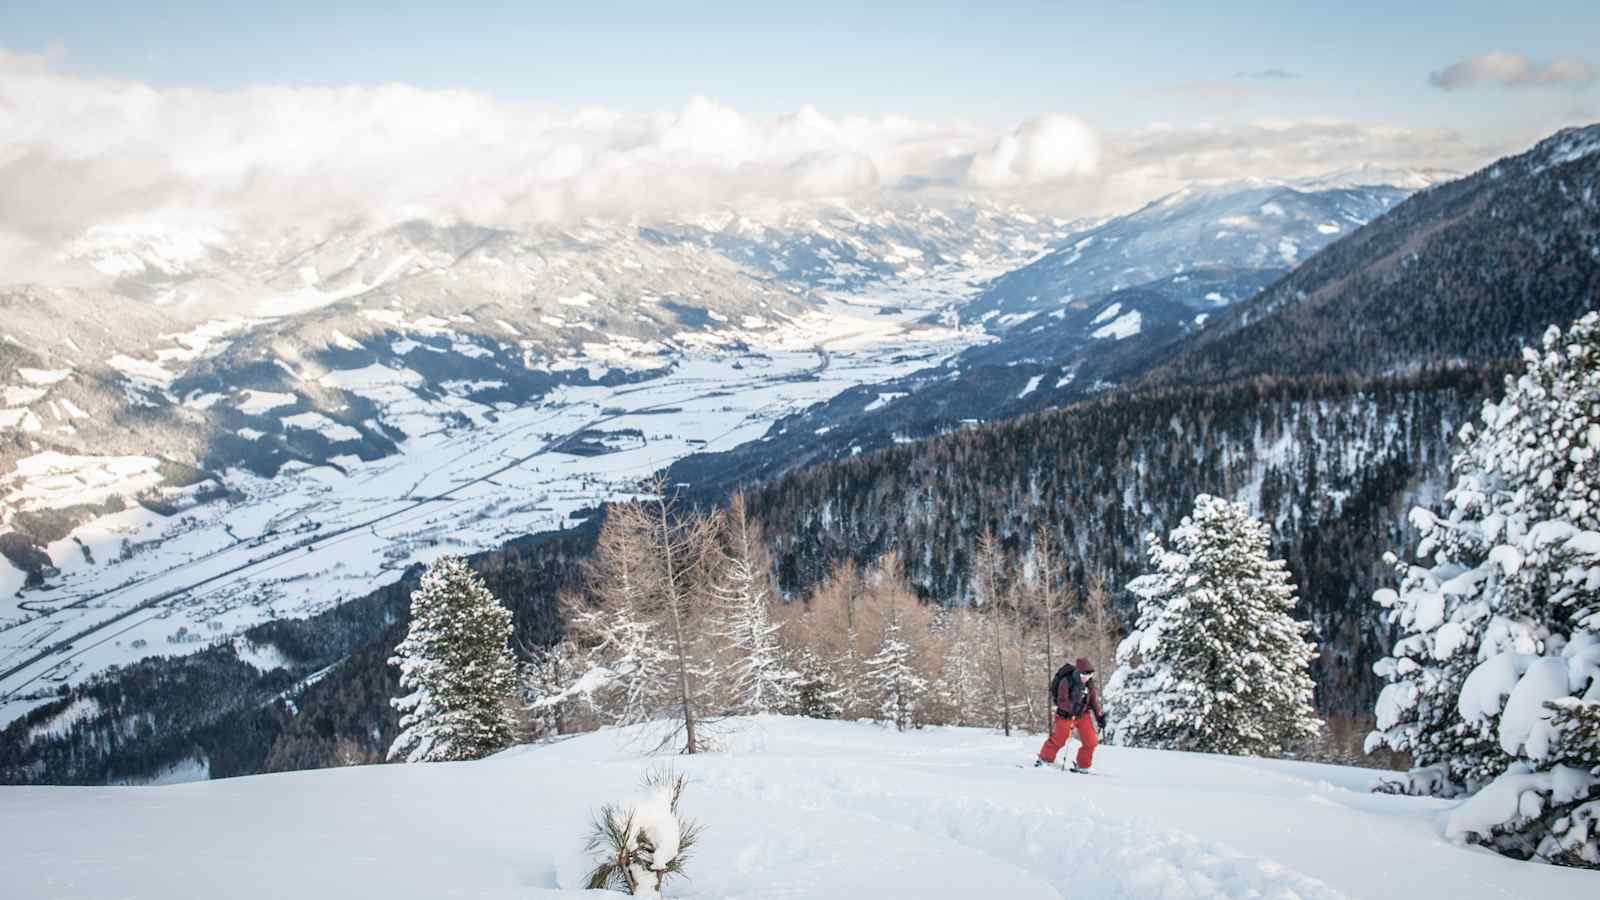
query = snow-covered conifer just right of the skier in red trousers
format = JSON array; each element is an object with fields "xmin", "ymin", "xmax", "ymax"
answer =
[{"xmin": 1106, "ymin": 495, "xmax": 1322, "ymax": 756}]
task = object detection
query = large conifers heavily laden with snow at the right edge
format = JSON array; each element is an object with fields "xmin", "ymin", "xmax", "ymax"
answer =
[{"xmin": 1370, "ymin": 312, "xmax": 1600, "ymax": 868}]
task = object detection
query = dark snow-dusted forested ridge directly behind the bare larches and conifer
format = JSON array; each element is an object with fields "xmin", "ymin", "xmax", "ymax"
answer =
[{"xmin": 736, "ymin": 368, "xmax": 1499, "ymax": 711}]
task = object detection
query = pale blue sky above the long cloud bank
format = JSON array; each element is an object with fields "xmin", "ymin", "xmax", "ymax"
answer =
[{"xmin": 0, "ymin": 0, "xmax": 1600, "ymax": 139}]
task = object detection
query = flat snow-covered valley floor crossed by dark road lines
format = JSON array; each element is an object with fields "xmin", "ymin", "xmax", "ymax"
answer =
[{"xmin": 0, "ymin": 269, "xmax": 981, "ymax": 724}]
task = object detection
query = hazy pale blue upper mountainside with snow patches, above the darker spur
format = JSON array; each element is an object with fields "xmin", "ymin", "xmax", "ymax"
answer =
[{"xmin": 963, "ymin": 178, "xmax": 1410, "ymax": 330}]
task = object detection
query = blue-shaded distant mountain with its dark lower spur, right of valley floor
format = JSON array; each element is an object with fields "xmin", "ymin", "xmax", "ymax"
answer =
[{"xmin": 674, "ymin": 168, "xmax": 1450, "ymax": 485}]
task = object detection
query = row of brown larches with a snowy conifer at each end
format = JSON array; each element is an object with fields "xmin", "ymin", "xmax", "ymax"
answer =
[{"xmin": 389, "ymin": 484, "xmax": 1323, "ymax": 762}]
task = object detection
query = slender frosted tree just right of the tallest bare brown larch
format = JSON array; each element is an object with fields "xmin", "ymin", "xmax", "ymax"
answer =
[{"xmin": 712, "ymin": 495, "xmax": 797, "ymax": 714}]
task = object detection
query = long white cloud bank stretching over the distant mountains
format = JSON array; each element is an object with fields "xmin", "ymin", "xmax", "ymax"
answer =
[{"xmin": 0, "ymin": 51, "xmax": 1490, "ymax": 280}]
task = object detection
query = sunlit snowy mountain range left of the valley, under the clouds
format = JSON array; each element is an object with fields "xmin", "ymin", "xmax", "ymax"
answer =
[{"xmin": 0, "ymin": 200, "xmax": 1067, "ymax": 566}]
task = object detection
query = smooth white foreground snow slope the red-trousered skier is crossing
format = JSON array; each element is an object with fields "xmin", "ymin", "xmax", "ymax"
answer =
[{"xmin": 0, "ymin": 717, "xmax": 1574, "ymax": 900}]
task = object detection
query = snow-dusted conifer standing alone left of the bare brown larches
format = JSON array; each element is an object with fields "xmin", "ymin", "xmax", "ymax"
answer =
[{"xmin": 389, "ymin": 556, "xmax": 517, "ymax": 762}]
